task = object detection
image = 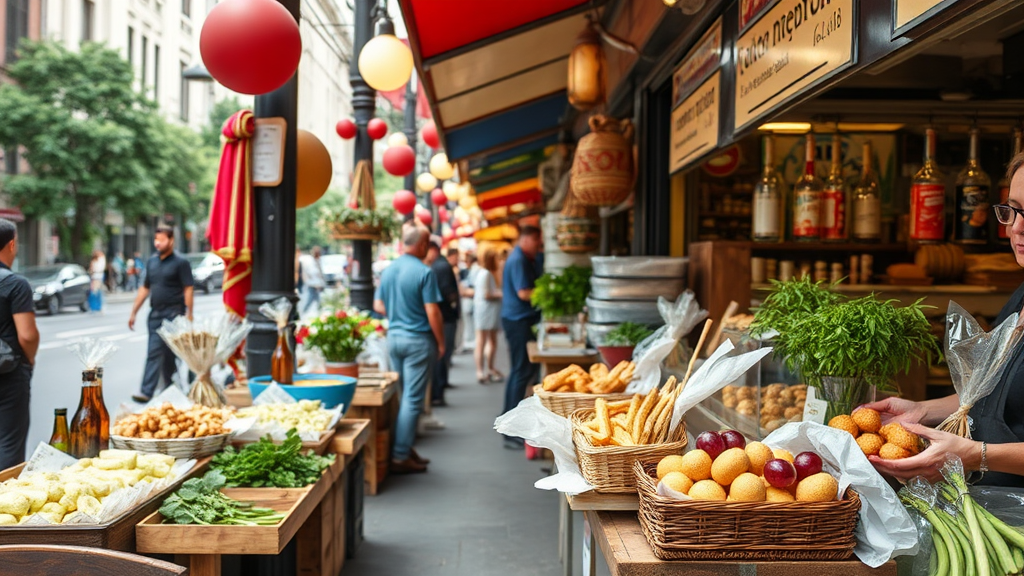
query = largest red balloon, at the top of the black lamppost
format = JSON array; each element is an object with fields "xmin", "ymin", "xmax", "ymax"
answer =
[{"xmin": 199, "ymin": 0, "xmax": 302, "ymax": 94}]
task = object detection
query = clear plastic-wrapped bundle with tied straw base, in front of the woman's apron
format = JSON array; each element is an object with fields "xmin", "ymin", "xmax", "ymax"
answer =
[{"xmin": 939, "ymin": 300, "xmax": 1024, "ymax": 438}]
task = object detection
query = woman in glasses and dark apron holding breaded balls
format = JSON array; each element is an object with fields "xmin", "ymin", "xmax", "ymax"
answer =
[{"xmin": 867, "ymin": 154, "xmax": 1024, "ymax": 488}]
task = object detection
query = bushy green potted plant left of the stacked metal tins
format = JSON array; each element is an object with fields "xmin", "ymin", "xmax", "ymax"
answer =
[{"xmin": 530, "ymin": 266, "xmax": 591, "ymax": 349}]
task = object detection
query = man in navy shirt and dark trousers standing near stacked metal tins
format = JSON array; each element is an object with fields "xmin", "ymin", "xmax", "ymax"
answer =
[{"xmin": 502, "ymin": 225, "xmax": 542, "ymax": 449}]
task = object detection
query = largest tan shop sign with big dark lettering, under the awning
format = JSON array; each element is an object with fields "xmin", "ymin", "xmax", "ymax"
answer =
[{"xmin": 734, "ymin": 0, "xmax": 857, "ymax": 130}]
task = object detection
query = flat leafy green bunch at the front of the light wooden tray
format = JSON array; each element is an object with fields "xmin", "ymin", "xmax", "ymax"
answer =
[{"xmin": 160, "ymin": 470, "xmax": 285, "ymax": 526}]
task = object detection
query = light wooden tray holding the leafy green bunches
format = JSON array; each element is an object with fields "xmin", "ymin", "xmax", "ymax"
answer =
[{"xmin": 135, "ymin": 450, "xmax": 345, "ymax": 554}]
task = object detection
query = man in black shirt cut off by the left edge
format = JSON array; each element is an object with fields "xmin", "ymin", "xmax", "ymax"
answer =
[{"xmin": 0, "ymin": 218, "xmax": 39, "ymax": 469}]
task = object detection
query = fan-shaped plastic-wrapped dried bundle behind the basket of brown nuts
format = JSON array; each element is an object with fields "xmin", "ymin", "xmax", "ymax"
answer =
[{"xmin": 157, "ymin": 315, "xmax": 252, "ymax": 408}]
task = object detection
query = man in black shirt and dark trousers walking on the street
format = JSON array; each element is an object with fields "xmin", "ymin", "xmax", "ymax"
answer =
[{"xmin": 128, "ymin": 225, "xmax": 193, "ymax": 403}]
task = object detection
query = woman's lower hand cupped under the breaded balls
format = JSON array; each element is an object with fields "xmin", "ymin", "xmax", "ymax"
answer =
[{"xmin": 867, "ymin": 420, "xmax": 981, "ymax": 482}]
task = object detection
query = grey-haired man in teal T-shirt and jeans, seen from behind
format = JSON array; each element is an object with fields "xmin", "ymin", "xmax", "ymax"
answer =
[{"xmin": 374, "ymin": 220, "xmax": 444, "ymax": 474}]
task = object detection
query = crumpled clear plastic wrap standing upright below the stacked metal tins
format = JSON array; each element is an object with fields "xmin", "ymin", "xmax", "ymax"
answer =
[{"xmin": 626, "ymin": 290, "xmax": 708, "ymax": 394}]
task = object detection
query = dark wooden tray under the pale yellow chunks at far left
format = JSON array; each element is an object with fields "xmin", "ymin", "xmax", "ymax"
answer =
[{"xmin": 0, "ymin": 458, "xmax": 210, "ymax": 552}]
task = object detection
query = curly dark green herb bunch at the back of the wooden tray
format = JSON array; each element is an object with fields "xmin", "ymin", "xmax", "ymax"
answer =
[{"xmin": 213, "ymin": 428, "xmax": 334, "ymax": 488}]
